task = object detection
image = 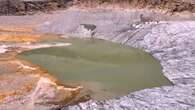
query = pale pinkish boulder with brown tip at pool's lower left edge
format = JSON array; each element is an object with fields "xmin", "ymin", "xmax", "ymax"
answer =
[{"xmin": 31, "ymin": 77, "xmax": 81, "ymax": 106}]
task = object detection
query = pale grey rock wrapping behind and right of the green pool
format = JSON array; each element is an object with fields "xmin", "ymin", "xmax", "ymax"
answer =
[{"xmin": 0, "ymin": 11, "xmax": 195, "ymax": 110}]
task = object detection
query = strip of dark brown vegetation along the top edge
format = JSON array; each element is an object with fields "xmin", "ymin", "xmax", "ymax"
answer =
[{"xmin": 0, "ymin": 0, "xmax": 195, "ymax": 15}]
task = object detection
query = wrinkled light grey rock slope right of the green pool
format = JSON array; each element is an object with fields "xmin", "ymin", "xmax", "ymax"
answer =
[{"xmin": 62, "ymin": 21, "xmax": 195, "ymax": 110}]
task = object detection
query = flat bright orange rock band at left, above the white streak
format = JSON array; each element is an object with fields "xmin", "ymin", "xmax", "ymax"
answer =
[{"xmin": 0, "ymin": 26, "xmax": 63, "ymax": 42}]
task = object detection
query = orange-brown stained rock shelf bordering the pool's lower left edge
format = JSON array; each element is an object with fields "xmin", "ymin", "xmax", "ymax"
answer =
[{"xmin": 0, "ymin": 59, "xmax": 80, "ymax": 103}]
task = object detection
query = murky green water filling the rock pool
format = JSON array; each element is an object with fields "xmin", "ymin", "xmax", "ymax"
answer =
[{"xmin": 19, "ymin": 39, "xmax": 171, "ymax": 100}]
